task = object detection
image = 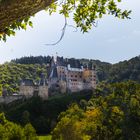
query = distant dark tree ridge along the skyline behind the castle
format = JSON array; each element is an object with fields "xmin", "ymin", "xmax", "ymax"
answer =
[{"xmin": 11, "ymin": 56, "xmax": 112, "ymax": 81}]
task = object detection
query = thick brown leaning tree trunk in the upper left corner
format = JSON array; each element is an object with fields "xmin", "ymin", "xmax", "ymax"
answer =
[{"xmin": 0, "ymin": 0, "xmax": 54, "ymax": 32}]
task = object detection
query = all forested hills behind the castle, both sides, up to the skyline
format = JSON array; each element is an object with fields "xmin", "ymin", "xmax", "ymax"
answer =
[{"xmin": 0, "ymin": 56, "xmax": 140, "ymax": 93}]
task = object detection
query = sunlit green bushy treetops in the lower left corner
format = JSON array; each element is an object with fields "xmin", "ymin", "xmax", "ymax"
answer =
[{"xmin": 0, "ymin": 113, "xmax": 37, "ymax": 140}]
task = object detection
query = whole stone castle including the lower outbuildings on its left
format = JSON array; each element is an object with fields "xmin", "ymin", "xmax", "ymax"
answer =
[{"xmin": 0, "ymin": 57, "xmax": 97, "ymax": 103}]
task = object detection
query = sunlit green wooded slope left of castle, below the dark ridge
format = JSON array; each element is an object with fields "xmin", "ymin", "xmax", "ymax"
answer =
[{"xmin": 0, "ymin": 62, "xmax": 47, "ymax": 94}]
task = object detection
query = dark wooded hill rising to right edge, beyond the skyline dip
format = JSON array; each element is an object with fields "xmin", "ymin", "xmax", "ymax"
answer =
[{"xmin": 109, "ymin": 56, "xmax": 140, "ymax": 82}]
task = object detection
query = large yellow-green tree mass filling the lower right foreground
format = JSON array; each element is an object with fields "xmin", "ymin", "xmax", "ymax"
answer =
[{"xmin": 52, "ymin": 82, "xmax": 140, "ymax": 140}]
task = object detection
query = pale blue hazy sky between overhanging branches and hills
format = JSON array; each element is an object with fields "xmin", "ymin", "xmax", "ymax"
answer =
[{"xmin": 0, "ymin": 0, "xmax": 140, "ymax": 63}]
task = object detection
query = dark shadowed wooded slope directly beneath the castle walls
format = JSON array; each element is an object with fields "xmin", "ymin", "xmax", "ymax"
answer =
[{"xmin": 0, "ymin": 91, "xmax": 92, "ymax": 135}]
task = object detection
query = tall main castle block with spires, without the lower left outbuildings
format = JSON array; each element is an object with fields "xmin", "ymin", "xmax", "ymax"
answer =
[{"xmin": 48, "ymin": 57, "xmax": 96, "ymax": 94}]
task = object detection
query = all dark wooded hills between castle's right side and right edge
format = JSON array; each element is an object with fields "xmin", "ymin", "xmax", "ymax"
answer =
[{"xmin": 81, "ymin": 56, "xmax": 140, "ymax": 83}]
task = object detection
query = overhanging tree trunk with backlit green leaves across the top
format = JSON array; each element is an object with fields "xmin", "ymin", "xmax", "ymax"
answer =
[{"xmin": 0, "ymin": 0, "xmax": 131, "ymax": 41}]
